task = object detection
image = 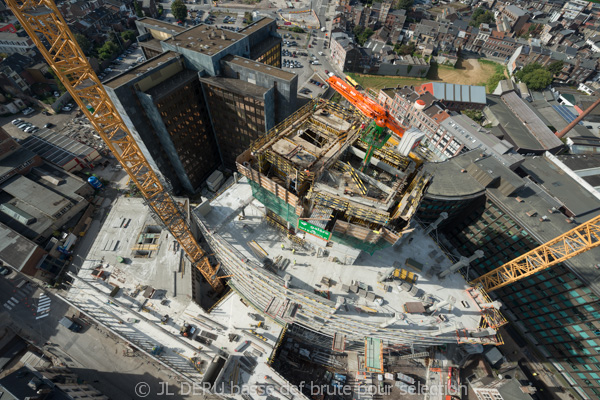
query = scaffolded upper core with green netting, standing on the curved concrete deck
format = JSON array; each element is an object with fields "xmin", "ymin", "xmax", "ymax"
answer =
[{"xmin": 237, "ymin": 98, "xmax": 430, "ymax": 258}]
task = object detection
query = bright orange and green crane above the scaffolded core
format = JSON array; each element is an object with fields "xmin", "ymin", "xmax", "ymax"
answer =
[{"xmin": 327, "ymin": 75, "xmax": 406, "ymax": 171}]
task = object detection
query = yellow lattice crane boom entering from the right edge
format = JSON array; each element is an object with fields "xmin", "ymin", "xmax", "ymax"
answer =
[{"xmin": 471, "ymin": 215, "xmax": 600, "ymax": 292}]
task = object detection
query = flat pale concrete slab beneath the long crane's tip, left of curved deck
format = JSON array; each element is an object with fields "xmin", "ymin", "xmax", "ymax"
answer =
[{"xmin": 68, "ymin": 197, "xmax": 282, "ymax": 382}]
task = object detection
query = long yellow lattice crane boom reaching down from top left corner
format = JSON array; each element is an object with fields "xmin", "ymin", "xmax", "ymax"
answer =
[{"xmin": 6, "ymin": 0, "xmax": 224, "ymax": 292}]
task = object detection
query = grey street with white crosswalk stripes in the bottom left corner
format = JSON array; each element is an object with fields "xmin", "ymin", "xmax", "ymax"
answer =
[{"xmin": 0, "ymin": 272, "xmax": 187, "ymax": 399}]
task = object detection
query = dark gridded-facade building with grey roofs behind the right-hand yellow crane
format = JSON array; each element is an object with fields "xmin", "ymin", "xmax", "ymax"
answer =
[{"xmin": 418, "ymin": 150, "xmax": 600, "ymax": 399}]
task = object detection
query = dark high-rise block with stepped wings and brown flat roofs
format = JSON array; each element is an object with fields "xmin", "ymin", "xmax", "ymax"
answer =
[{"xmin": 105, "ymin": 18, "xmax": 298, "ymax": 193}]
